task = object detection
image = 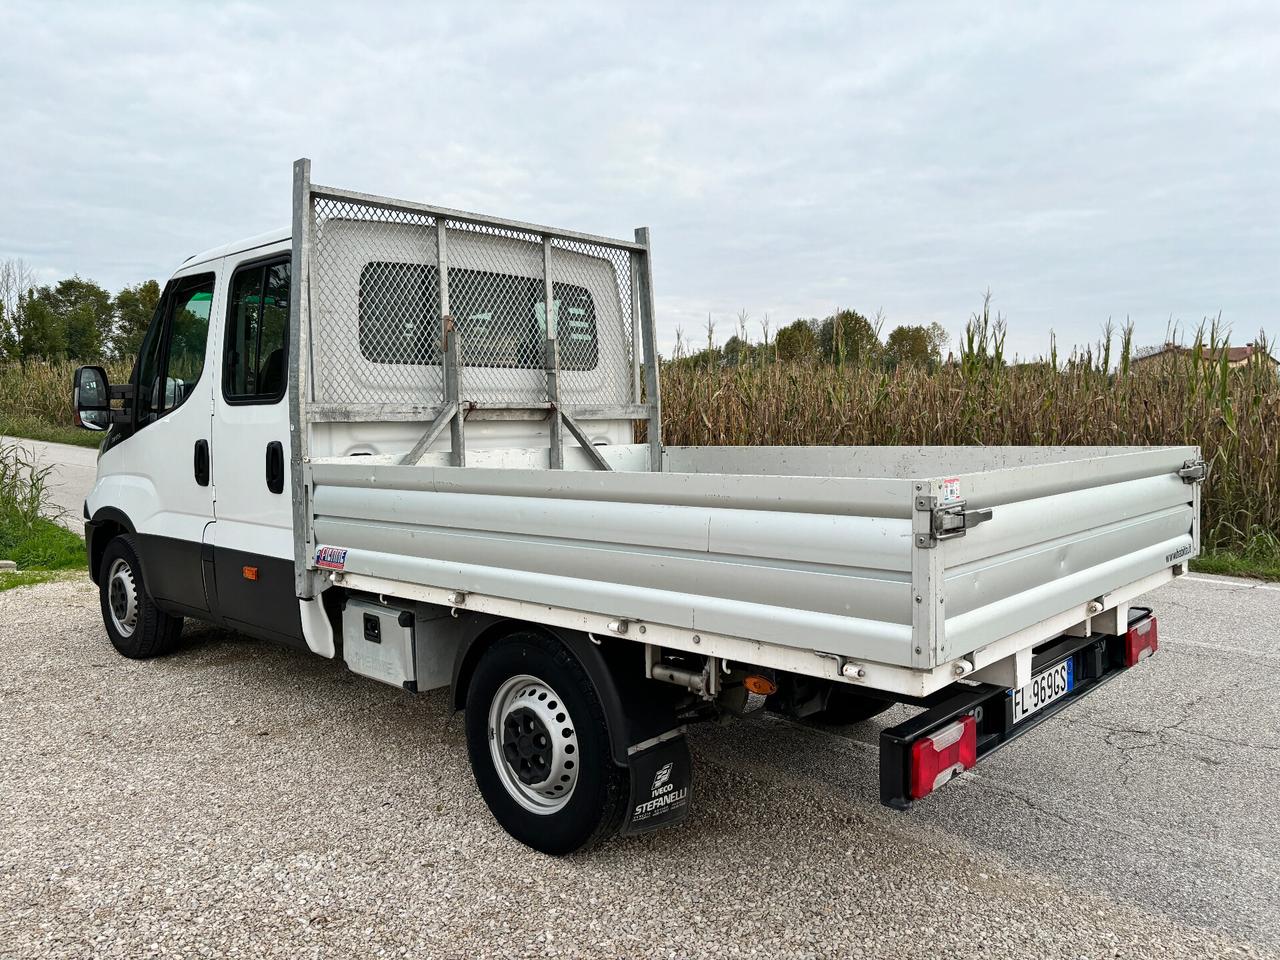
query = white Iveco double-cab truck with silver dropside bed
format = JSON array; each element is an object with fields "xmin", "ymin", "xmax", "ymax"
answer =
[{"xmin": 74, "ymin": 160, "xmax": 1204, "ymax": 854}]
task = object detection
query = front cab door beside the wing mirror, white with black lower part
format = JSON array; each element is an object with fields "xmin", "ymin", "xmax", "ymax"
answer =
[{"xmin": 113, "ymin": 264, "xmax": 218, "ymax": 617}]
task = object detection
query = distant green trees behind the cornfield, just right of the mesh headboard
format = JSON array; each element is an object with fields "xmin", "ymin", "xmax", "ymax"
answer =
[{"xmin": 671, "ymin": 308, "xmax": 951, "ymax": 369}]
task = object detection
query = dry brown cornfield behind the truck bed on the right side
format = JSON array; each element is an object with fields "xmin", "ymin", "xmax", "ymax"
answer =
[{"xmin": 662, "ymin": 323, "xmax": 1280, "ymax": 553}]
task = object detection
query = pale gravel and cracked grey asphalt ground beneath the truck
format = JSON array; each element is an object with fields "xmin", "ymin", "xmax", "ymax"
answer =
[{"xmin": 0, "ymin": 579, "xmax": 1280, "ymax": 960}]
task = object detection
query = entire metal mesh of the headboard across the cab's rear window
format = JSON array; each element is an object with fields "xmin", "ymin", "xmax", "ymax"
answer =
[{"xmin": 302, "ymin": 192, "xmax": 637, "ymax": 407}]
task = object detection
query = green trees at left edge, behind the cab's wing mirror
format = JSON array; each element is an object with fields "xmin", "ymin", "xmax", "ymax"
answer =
[{"xmin": 0, "ymin": 260, "xmax": 160, "ymax": 364}]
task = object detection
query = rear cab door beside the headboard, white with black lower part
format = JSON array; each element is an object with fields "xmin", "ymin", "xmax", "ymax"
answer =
[{"xmin": 212, "ymin": 241, "xmax": 305, "ymax": 645}]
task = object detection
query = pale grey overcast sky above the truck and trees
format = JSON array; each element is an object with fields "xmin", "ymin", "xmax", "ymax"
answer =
[{"xmin": 0, "ymin": 0, "xmax": 1280, "ymax": 356}]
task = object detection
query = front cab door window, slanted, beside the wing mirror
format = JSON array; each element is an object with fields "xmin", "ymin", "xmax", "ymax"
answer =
[{"xmin": 136, "ymin": 274, "xmax": 214, "ymax": 426}]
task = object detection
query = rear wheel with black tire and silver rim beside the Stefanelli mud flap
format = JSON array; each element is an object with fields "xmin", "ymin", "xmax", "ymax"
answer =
[{"xmin": 466, "ymin": 631, "xmax": 627, "ymax": 856}]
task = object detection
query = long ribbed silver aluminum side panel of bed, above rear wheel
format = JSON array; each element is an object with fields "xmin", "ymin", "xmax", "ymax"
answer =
[{"xmin": 314, "ymin": 486, "xmax": 911, "ymax": 663}]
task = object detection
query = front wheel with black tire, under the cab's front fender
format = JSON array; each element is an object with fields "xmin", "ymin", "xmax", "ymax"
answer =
[{"xmin": 99, "ymin": 535, "xmax": 182, "ymax": 660}]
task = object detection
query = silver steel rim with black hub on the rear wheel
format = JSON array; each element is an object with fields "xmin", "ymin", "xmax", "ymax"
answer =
[{"xmin": 489, "ymin": 673, "xmax": 581, "ymax": 815}]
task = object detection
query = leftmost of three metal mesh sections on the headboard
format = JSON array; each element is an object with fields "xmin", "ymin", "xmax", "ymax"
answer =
[{"xmin": 311, "ymin": 197, "xmax": 444, "ymax": 404}]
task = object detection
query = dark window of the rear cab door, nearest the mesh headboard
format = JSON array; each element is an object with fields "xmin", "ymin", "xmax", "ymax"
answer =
[{"xmin": 223, "ymin": 259, "xmax": 289, "ymax": 403}]
